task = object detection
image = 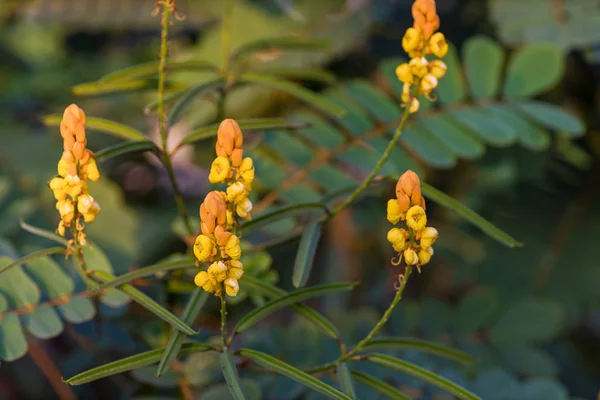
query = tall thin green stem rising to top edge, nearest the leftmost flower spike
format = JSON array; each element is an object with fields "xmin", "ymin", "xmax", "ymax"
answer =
[{"xmin": 158, "ymin": 1, "xmax": 194, "ymax": 236}]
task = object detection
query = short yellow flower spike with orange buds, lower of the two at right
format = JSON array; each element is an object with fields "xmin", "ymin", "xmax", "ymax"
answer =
[{"xmin": 387, "ymin": 170, "xmax": 438, "ymax": 269}]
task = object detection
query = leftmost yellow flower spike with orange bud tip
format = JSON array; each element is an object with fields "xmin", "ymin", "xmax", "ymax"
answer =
[{"xmin": 50, "ymin": 104, "xmax": 100, "ymax": 245}]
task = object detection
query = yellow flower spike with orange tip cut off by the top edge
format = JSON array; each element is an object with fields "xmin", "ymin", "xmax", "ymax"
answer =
[{"xmin": 396, "ymin": 0, "xmax": 448, "ymax": 113}]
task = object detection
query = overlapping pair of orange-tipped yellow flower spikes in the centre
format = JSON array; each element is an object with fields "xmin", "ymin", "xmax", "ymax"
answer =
[{"xmin": 194, "ymin": 119, "xmax": 254, "ymax": 296}]
